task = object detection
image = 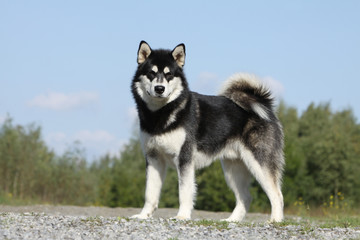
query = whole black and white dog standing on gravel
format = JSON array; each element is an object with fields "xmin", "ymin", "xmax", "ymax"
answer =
[{"xmin": 131, "ymin": 41, "xmax": 285, "ymax": 222}]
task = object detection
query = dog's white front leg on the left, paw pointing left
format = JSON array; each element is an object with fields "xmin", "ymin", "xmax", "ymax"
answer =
[{"xmin": 132, "ymin": 158, "xmax": 166, "ymax": 219}]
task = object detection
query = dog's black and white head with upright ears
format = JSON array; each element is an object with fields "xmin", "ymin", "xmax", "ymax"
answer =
[{"xmin": 132, "ymin": 41, "xmax": 187, "ymax": 111}]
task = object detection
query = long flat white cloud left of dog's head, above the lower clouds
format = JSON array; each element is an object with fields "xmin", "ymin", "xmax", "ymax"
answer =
[{"xmin": 27, "ymin": 92, "xmax": 99, "ymax": 110}]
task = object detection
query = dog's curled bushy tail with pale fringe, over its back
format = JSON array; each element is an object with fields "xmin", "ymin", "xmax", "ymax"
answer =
[{"xmin": 219, "ymin": 73, "xmax": 274, "ymax": 120}]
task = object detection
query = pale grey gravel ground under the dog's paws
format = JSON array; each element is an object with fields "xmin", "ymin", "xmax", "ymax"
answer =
[{"xmin": 0, "ymin": 206, "xmax": 360, "ymax": 240}]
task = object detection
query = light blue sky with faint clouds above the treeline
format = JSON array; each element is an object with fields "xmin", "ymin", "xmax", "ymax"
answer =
[{"xmin": 0, "ymin": 0, "xmax": 360, "ymax": 159}]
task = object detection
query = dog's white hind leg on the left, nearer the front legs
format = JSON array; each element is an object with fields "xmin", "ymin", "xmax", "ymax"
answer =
[{"xmin": 221, "ymin": 159, "xmax": 251, "ymax": 222}]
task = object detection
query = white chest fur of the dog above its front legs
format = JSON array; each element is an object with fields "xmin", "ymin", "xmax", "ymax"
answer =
[{"xmin": 140, "ymin": 128, "xmax": 186, "ymax": 165}]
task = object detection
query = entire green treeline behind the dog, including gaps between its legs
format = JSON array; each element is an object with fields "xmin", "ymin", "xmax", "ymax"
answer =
[{"xmin": 0, "ymin": 103, "xmax": 360, "ymax": 211}]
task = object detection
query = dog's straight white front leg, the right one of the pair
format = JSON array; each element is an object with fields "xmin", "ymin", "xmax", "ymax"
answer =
[{"xmin": 175, "ymin": 163, "xmax": 196, "ymax": 220}]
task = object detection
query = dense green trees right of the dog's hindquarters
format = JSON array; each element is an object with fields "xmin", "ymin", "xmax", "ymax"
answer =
[{"xmin": 285, "ymin": 104, "xmax": 360, "ymax": 206}]
